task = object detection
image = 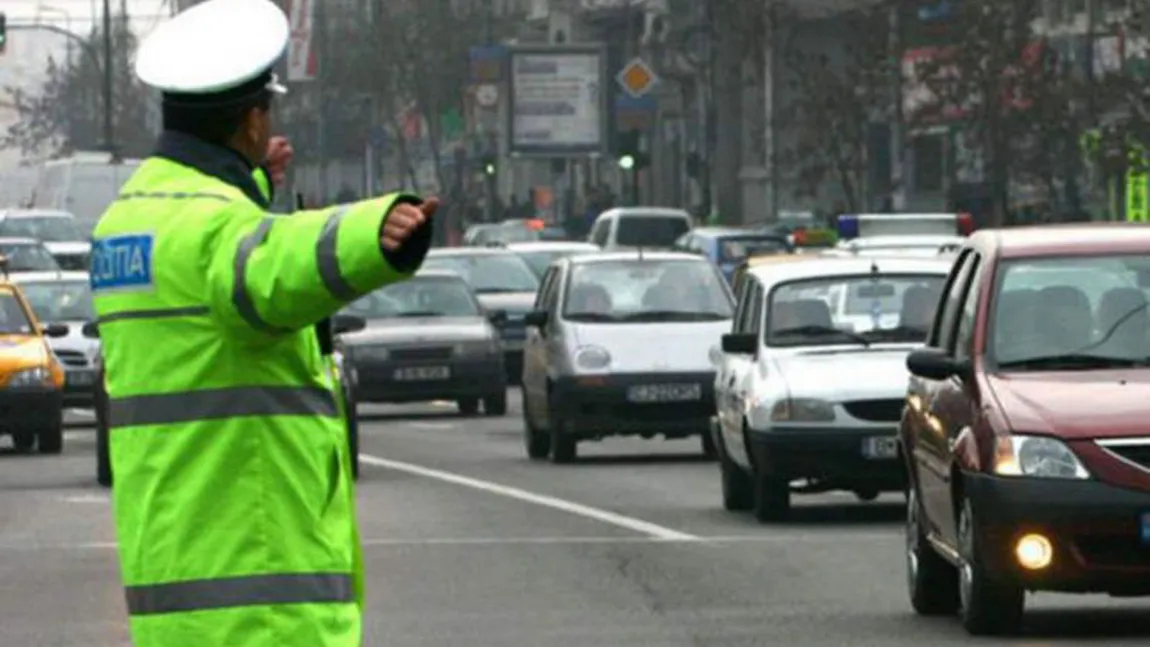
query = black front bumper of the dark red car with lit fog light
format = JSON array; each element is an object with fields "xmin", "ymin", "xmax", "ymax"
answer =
[{"xmin": 963, "ymin": 473, "xmax": 1150, "ymax": 595}]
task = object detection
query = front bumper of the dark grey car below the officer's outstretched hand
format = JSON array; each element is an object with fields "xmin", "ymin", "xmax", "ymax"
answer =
[{"xmin": 354, "ymin": 355, "xmax": 507, "ymax": 403}]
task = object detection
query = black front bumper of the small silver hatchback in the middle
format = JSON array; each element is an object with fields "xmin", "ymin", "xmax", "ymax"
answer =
[{"xmin": 553, "ymin": 372, "xmax": 715, "ymax": 438}]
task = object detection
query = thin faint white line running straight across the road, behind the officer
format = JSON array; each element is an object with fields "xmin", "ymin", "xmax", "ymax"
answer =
[{"xmin": 0, "ymin": 532, "xmax": 902, "ymax": 552}]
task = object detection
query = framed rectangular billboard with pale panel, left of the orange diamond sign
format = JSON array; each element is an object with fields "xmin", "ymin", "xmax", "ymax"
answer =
[{"xmin": 507, "ymin": 45, "xmax": 608, "ymax": 157}]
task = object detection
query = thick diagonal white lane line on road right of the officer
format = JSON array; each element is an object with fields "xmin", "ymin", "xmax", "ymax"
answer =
[{"xmin": 360, "ymin": 454, "xmax": 702, "ymax": 541}]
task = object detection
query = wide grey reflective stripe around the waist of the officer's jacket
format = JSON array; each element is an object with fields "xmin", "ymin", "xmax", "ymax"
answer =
[{"xmin": 108, "ymin": 386, "xmax": 339, "ymax": 426}]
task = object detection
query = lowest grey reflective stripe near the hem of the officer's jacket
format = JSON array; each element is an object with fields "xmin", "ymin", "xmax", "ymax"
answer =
[{"xmin": 124, "ymin": 573, "xmax": 355, "ymax": 616}]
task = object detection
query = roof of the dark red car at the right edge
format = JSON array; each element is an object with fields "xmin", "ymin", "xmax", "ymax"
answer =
[{"xmin": 969, "ymin": 223, "xmax": 1150, "ymax": 257}]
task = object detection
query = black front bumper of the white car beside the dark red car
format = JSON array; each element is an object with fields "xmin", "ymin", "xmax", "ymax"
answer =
[{"xmin": 749, "ymin": 423, "xmax": 906, "ymax": 492}]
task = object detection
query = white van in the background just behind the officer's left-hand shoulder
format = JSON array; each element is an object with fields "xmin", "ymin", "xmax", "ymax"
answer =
[{"xmin": 33, "ymin": 153, "xmax": 140, "ymax": 236}]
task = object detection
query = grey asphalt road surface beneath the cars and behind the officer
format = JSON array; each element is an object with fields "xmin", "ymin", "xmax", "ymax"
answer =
[{"xmin": 0, "ymin": 393, "xmax": 1150, "ymax": 647}]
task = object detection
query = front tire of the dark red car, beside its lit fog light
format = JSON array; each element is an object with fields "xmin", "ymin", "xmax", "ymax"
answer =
[{"xmin": 958, "ymin": 496, "xmax": 1026, "ymax": 636}]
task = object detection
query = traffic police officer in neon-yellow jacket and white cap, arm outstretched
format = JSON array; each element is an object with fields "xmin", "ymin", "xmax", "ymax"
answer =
[{"xmin": 91, "ymin": 0, "xmax": 437, "ymax": 647}]
